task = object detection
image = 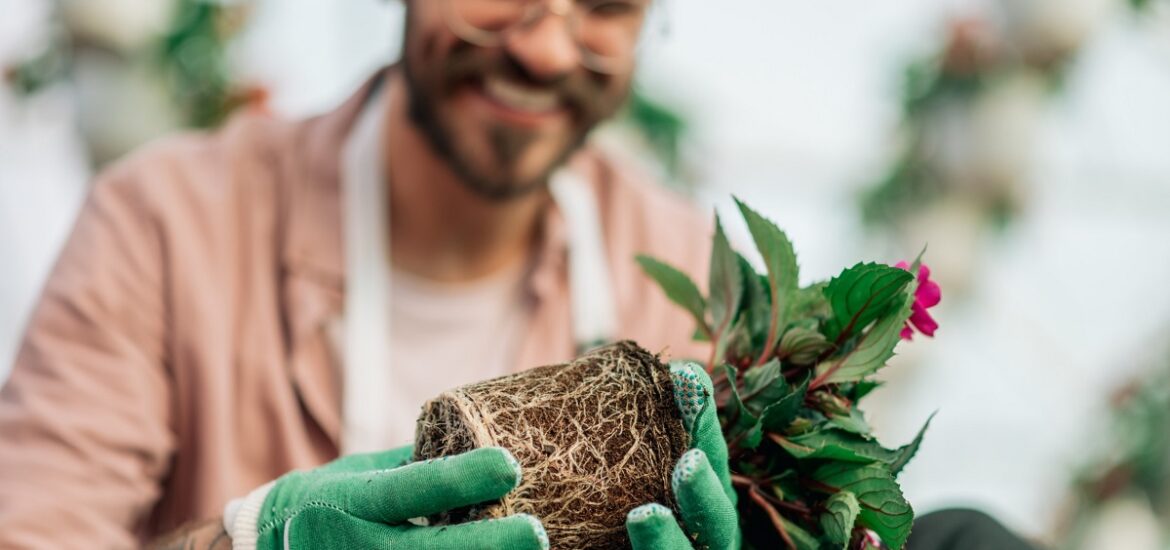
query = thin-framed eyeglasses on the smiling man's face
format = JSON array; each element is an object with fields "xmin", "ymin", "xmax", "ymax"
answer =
[{"xmin": 445, "ymin": 0, "xmax": 649, "ymax": 73}]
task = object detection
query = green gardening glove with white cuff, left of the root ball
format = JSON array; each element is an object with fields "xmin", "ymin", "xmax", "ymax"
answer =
[{"xmin": 225, "ymin": 447, "xmax": 549, "ymax": 550}]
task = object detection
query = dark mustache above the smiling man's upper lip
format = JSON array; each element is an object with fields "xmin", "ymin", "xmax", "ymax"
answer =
[{"xmin": 440, "ymin": 42, "xmax": 607, "ymax": 121}]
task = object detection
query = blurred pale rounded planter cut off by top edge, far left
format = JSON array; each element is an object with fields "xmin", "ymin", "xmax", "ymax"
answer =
[{"xmin": 61, "ymin": 0, "xmax": 176, "ymax": 51}]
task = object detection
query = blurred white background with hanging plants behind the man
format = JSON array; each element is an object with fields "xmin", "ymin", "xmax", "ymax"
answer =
[{"xmin": 0, "ymin": 0, "xmax": 1170, "ymax": 549}]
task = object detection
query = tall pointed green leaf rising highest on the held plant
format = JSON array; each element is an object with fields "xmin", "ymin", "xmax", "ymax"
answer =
[{"xmin": 735, "ymin": 199, "xmax": 800, "ymax": 357}]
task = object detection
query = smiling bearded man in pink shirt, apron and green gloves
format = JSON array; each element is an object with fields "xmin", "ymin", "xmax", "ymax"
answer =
[{"xmin": 0, "ymin": 0, "xmax": 735, "ymax": 549}]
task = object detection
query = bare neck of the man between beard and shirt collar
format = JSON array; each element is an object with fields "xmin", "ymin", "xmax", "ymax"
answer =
[{"xmin": 381, "ymin": 73, "xmax": 551, "ymax": 282}]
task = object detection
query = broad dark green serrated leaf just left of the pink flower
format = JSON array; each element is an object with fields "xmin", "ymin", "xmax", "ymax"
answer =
[{"xmin": 825, "ymin": 263, "xmax": 914, "ymax": 343}]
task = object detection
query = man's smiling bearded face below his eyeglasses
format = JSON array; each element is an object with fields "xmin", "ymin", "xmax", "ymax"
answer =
[{"xmin": 402, "ymin": 0, "xmax": 633, "ymax": 200}]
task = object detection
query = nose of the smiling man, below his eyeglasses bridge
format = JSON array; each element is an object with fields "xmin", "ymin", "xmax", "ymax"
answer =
[{"xmin": 504, "ymin": 7, "xmax": 581, "ymax": 81}]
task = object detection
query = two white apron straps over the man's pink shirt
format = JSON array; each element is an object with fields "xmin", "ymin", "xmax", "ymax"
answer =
[{"xmin": 339, "ymin": 83, "xmax": 617, "ymax": 454}]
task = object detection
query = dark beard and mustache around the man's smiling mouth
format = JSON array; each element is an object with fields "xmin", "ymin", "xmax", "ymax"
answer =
[{"xmin": 402, "ymin": 26, "xmax": 628, "ymax": 201}]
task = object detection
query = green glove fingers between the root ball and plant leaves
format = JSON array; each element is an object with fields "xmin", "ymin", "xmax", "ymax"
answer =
[{"xmin": 626, "ymin": 362, "xmax": 739, "ymax": 550}]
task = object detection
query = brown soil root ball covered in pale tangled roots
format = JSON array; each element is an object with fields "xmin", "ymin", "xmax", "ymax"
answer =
[{"xmin": 414, "ymin": 342, "xmax": 689, "ymax": 549}]
